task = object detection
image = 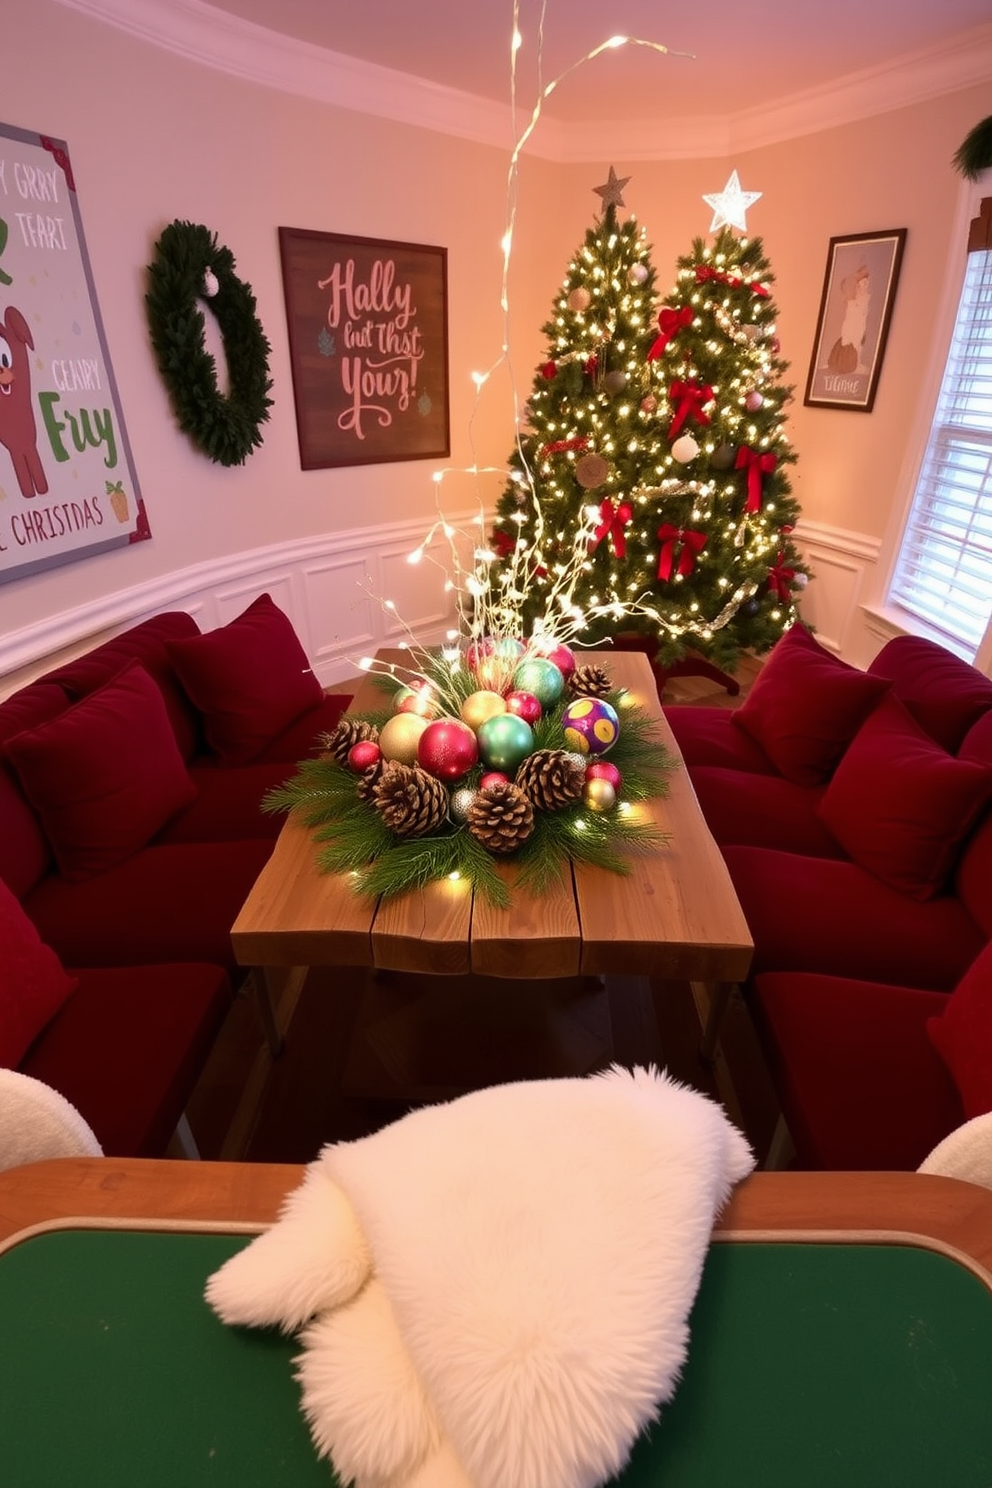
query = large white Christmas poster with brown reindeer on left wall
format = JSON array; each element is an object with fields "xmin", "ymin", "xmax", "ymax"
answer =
[{"xmin": 0, "ymin": 124, "xmax": 152, "ymax": 583}]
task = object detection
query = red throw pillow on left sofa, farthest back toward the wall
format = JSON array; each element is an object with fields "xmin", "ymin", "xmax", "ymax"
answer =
[{"xmin": 168, "ymin": 594, "xmax": 324, "ymax": 765}]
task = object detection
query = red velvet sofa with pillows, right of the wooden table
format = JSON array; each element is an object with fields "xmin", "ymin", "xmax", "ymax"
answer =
[{"xmin": 665, "ymin": 626, "xmax": 992, "ymax": 1168}]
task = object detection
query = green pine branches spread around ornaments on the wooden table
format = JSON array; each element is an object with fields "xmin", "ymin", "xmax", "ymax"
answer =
[{"xmin": 262, "ymin": 683, "xmax": 677, "ymax": 908}]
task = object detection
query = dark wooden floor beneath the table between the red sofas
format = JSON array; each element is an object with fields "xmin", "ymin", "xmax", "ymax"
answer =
[{"xmin": 180, "ymin": 662, "xmax": 778, "ymax": 1162}]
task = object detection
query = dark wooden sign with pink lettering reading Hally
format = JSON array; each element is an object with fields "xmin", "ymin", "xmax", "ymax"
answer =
[{"xmin": 280, "ymin": 228, "xmax": 451, "ymax": 470}]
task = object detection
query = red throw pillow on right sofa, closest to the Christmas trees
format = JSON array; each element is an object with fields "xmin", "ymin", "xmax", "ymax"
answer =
[{"xmin": 732, "ymin": 625, "xmax": 891, "ymax": 786}]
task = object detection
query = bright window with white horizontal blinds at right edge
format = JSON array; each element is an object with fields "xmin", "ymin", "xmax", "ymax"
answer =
[{"xmin": 888, "ymin": 188, "xmax": 992, "ymax": 661}]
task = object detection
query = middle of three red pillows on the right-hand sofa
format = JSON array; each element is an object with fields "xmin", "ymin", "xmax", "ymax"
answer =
[{"xmin": 819, "ymin": 696, "xmax": 992, "ymax": 899}]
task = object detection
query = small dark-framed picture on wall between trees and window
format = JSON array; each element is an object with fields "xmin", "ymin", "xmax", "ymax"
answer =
[{"xmin": 803, "ymin": 228, "xmax": 906, "ymax": 414}]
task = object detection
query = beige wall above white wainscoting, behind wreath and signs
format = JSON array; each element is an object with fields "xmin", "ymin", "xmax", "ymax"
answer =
[{"xmin": 0, "ymin": 0, "xmax": 988, "ymax": 673}]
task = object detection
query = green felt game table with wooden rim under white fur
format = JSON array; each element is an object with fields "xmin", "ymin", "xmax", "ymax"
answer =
[{"xmin": 0, "ymin": 1159, "xmax": 992, "ymax": 1488}]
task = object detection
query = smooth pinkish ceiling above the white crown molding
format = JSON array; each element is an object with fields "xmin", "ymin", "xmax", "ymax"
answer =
[{"xmin": 203, "ymin": 0, "xmax": 992, "ymax": 125}]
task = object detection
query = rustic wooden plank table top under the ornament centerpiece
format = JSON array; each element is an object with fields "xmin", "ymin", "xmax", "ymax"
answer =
[{"xmin": 232, "ymin": 652, "xmax": 753, "ymax": 988}]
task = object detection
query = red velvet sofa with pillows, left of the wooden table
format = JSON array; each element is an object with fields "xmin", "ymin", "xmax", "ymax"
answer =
[{"xmin": 0, "ymin": 595, "xmax": 350, "ymax": 1156}]
